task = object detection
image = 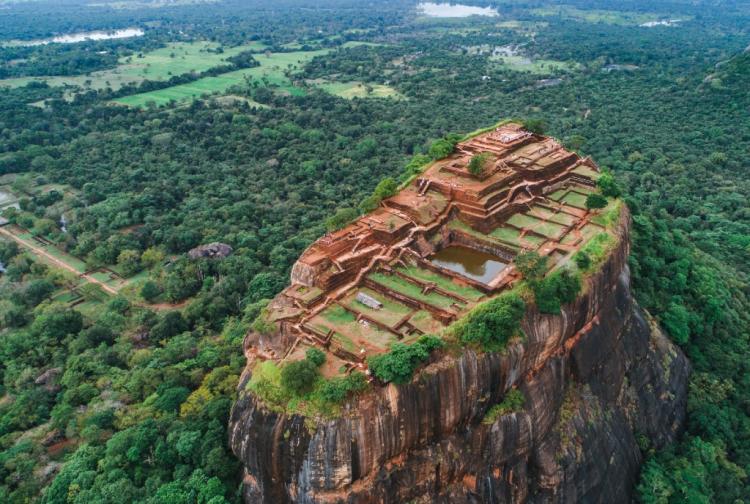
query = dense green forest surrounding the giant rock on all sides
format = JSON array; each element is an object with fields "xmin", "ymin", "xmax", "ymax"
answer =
[{"xmin": 0, "ymin": 0, "xmax": 750, "ymax": 504}]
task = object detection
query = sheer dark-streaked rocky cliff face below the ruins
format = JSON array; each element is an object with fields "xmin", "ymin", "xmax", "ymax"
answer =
[{"xmin": 230, "ymin": 216, "xmax": 689, "ymax": 504}]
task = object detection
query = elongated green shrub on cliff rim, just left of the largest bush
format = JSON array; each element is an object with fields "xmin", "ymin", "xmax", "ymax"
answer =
[{"xmin": 368, "ymin": 336, "xmax": 443, "ymax": 383}]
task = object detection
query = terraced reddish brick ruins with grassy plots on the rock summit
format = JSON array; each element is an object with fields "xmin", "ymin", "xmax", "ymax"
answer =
[{"xmin": 253, "ymin": 123, "xmax": 604, "ymax": 375}]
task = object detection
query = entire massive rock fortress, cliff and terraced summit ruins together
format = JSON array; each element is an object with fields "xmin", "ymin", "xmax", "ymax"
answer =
[{"xmin": 230, "ymin": 122, "xmax": 689, "ymax": 503}]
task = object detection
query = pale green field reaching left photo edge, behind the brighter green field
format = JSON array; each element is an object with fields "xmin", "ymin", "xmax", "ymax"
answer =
[{"xmin": 0, "ymin": 41, "xmax": 264, "ymax": 90}]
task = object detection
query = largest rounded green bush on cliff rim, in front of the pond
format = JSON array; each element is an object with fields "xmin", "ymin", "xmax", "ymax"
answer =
[{"xmin": 453, "ymin": 291, "xmax": 526, "ymax": 351}]
